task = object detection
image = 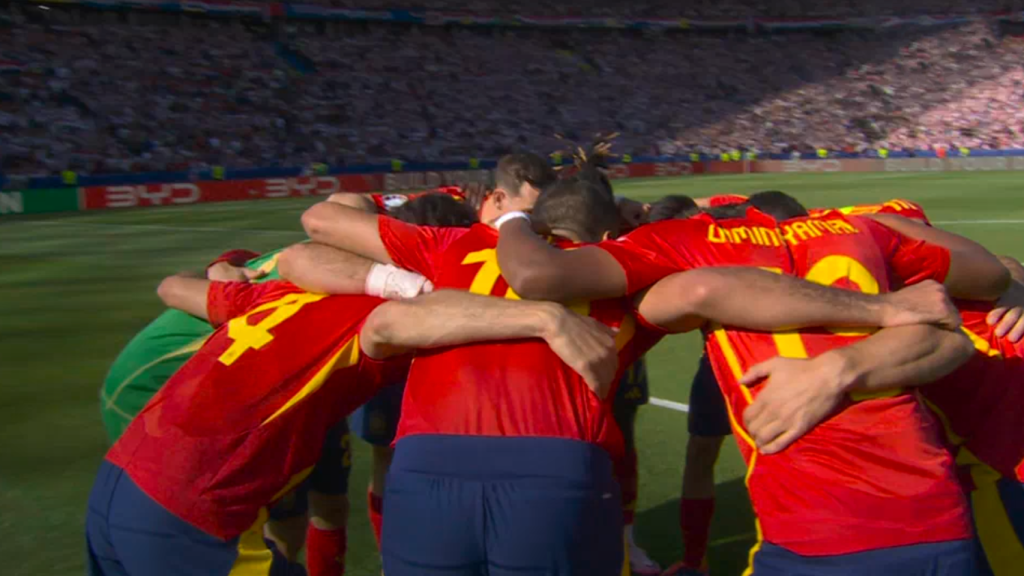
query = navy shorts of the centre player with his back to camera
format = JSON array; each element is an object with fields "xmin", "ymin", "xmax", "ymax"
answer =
[{"xmin": 382, "ymin": 435, "xmax": 624, "ymax": 576}]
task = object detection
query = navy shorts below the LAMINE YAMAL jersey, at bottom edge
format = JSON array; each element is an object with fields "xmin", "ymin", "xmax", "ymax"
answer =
[{"xmin": 754, "ymin": 528, "xmax": 978, "ymax": 576}]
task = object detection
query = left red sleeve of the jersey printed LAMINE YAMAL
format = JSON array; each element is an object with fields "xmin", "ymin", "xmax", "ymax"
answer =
[{"xmin": 597, "ymin": 220, "xmax": 693, "ymax": 295}]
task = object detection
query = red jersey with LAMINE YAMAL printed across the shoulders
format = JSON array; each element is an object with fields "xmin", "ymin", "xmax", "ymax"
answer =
[{"xmin": 600, "ymin": 210, "xmax": 971, "ymax": 556}]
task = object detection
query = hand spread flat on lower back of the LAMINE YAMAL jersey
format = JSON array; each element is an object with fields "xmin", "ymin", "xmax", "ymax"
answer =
[{"xmin": 739, "ymin": 353, "xmax": 850, "ymax": 454}]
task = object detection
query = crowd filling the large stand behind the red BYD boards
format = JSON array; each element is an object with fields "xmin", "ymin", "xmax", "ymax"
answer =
[{"xmin": 0, "ymin": 10, "xmax": 1024, "ymax": 175}]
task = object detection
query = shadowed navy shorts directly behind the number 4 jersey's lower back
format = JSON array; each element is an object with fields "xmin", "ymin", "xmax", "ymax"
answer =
[{"xmin": 270, "ymin": 420, "xmax": 352, "ymax": 521}]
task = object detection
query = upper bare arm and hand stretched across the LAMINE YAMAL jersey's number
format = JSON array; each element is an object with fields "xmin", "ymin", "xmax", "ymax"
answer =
[{"xmin": 637, "ymin": 266, "xmax": 961, "ymax": 332}]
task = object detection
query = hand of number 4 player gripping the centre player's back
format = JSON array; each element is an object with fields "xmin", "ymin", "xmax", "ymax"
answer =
[{"xmin": 544, "ymin": 306, "xmax": 618, "ymax": 400}]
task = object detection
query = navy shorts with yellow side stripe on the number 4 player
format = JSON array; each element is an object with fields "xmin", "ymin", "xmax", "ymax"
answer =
[{"xmin": 85, "ymin": 460, "xmax": 289, "ymax": 576}]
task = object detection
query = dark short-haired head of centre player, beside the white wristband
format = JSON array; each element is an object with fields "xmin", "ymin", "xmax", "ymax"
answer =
[{"xmin": 532, "ymin": 176, "xmax": 620, "ymax": 242}]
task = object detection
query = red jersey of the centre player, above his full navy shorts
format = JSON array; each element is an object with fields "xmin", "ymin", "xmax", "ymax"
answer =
[{"xmin": 379, "ymin": 216, "xmax": 660, "ymax": 457}]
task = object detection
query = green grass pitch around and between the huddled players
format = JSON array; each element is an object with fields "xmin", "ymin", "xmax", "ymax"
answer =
[{"xmin": 0, "ymin": 172, "xmax": 1024, "ymax": 576}]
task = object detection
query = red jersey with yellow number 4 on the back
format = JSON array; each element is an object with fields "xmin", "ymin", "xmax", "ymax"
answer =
[{"xmin": 106, "ymin": 281, "xmax": 408, "ymax": 539}]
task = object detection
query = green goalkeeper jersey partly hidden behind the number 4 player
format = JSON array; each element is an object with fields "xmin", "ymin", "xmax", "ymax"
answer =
[{"xmin": 99, "ymin": 250, "xmax": 282, "ymax": 444}]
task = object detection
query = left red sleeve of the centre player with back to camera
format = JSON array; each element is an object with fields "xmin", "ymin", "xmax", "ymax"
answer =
[{"xmin": 377, "ymin": 216, "xmax": 469, "ymax": 281}]
